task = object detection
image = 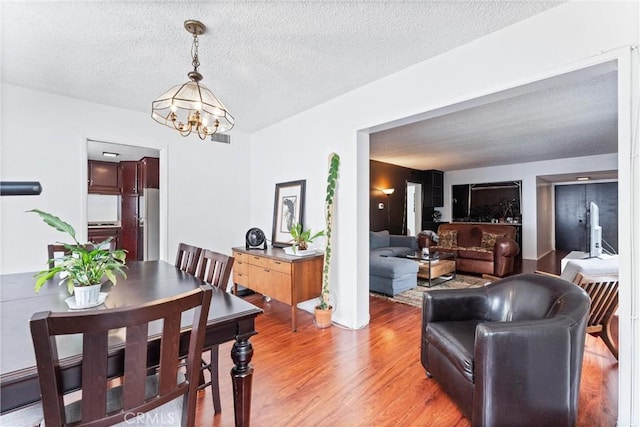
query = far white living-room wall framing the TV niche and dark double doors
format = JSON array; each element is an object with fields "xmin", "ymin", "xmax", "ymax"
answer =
[{"xmin": 442, "ymin": 153, "xmax": 618, "ymax": 259}]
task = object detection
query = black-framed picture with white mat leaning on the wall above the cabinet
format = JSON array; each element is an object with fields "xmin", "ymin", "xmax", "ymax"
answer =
[{"xmin": 271, "ymin": 179, "xmax": 307, "ymax": 248}]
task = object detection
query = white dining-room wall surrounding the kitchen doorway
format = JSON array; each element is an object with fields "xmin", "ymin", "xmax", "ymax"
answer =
[{"xmin": 0, "ymin": 84, "xmax": 250, "ymax": 274}]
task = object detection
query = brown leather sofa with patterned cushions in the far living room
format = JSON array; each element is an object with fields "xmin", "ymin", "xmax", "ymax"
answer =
[{"xmin": 418, "ymin": 223, "xmax": 520, "ymax": 277}]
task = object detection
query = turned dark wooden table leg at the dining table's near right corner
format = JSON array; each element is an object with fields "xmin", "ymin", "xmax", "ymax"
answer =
[{"xmin": 231, "ymin": 335, "xmax": 253, "ymax": 427}]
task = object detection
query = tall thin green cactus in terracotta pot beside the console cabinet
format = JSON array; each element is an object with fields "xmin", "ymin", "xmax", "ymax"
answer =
[{"xmin": 315, "ymin": 153, "xmax": 340, "ymax": 328}]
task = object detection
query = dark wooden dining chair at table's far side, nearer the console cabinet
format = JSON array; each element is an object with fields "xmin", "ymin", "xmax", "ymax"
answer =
[{"xmin": 196, "ymin": 249, "xmax": 234, "ymax": 414}]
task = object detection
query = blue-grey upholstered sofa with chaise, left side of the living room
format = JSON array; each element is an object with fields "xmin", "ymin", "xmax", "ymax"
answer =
[{"xmin": 369, "ymin": 230, "xmax": 419, "ymax": 296}]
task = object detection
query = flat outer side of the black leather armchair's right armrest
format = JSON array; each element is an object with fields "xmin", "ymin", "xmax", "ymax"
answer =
[{"xmin": 472, "ymin": 316, "xmax": 582, "ymax": 425}]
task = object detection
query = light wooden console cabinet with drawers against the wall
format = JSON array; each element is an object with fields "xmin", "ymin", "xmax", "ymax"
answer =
[{"xmin": 233, "ymin": 248, "xmax": 323, "ymax": 332}]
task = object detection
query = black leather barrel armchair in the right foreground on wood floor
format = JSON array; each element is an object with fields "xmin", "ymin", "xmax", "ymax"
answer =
[{"xmin": 421, "ymin": 274, "xmax": 590, "ymax": 426}]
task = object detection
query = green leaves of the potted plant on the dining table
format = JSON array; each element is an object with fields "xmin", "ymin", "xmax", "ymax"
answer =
[{"xmin": 28, "ymin": 209, "xmax": 127, "ymax": 294}]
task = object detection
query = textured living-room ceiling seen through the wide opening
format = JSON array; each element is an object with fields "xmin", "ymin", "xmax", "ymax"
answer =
[{"xmin": 370, "ymin": 63, "xmax": 618, "ymax": 171}]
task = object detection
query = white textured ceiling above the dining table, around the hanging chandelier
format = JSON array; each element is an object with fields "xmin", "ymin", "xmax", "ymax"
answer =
[{"xmin": 1, "ymin": 0, "xmax": 564, "ymax": 132}]
